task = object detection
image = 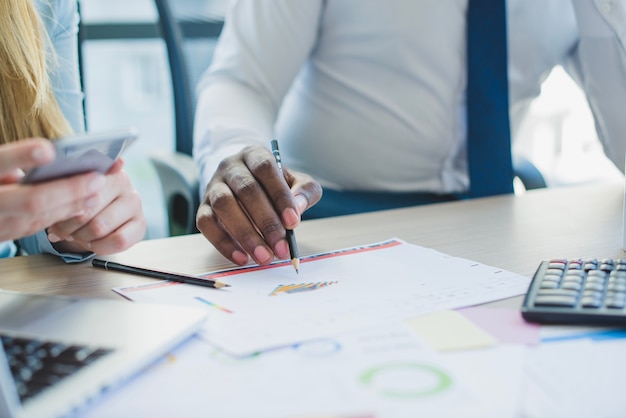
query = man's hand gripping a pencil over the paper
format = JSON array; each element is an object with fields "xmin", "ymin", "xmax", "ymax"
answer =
[{"xmin": 196, "ymin": 146, "xmax": 322, "ymax": 265}]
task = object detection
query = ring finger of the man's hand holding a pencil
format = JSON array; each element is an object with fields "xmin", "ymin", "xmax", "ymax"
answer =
[{"xmin": 200, "ymin": 182, "xmax": 274, "ymax": 264}]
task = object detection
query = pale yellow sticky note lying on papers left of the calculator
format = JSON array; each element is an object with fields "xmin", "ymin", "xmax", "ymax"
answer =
[{"xmin": 405, "ymin": 311, "xmax": 497, "ymax": 351}]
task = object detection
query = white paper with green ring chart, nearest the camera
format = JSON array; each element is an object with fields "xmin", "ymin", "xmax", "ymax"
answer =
[{"xmin": 85, "ymin": 323, "xmax": 521, "ymax": 418}]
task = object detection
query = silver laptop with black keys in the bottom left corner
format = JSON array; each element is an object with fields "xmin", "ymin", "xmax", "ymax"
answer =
[{"xmin": 0, "ymin": 290, "xmax": 206, "ymax": 418}]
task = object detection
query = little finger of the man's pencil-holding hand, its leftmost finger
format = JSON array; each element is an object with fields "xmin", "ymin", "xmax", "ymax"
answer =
[{"xmin": 196, "ymin": 204, "xmax": 250, "ymax": 266}]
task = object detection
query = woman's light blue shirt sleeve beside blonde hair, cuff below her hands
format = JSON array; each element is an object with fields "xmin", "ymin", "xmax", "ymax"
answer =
[{"xmin": 19, "ymin": 0, "xmax": 93, "ymax": 263}]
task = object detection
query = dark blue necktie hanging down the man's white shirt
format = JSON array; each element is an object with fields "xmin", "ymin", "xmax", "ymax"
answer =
[{"xmin": 467, "ymin": 0, "xmax": 513, "ymax": 197}]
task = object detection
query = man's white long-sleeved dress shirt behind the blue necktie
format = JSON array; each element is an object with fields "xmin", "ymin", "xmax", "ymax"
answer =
[{"xmin": 194, "ymin": 0, "xmax": 626, "ymax": 193}]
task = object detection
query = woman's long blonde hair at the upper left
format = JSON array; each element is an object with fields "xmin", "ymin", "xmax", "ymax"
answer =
[{"xmin": 0, "ymin": 0, "xmax": 71, "ymax": 144}]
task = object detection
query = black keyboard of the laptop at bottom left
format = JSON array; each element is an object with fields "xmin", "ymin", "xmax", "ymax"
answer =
[{"xmin": 0, "ymin": 335, "xmax": 112, "ymax": 402}]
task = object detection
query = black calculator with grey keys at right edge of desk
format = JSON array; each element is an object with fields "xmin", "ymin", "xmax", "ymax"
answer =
[{"xmin": 522, "ymin": 258, "xmax": 626, "ymax": 326}]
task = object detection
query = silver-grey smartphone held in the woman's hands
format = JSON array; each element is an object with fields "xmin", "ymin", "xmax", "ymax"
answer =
[{"xmin": 22, "ymin": 128, "xmax": 138, "ymax": 183}]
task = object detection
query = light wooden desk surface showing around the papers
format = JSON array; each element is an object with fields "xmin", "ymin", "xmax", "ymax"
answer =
[{"xmin": 0, "ymin": 184, "xmax": 624, "ymax": 306}]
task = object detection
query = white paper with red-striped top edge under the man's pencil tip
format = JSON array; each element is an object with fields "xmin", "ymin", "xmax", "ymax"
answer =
[{"xmin": 114, "ymin": 239, "xmax": 530, "ymax": 356}]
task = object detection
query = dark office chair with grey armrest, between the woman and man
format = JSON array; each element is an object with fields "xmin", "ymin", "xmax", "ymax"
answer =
[{"xmin": 150, "ymin": 0, "xmax": 222, "ymax": 236}]
